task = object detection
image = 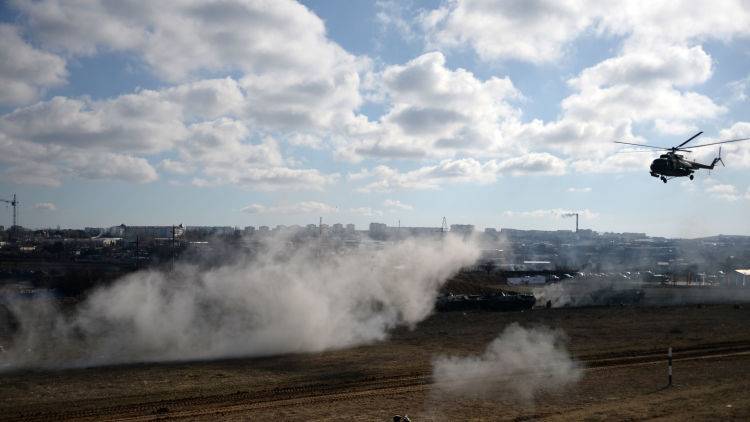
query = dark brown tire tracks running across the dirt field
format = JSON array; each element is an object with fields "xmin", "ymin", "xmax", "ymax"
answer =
[{"xmin": 8, "ymin": 341, "xmax": 750, "ymax": 421}]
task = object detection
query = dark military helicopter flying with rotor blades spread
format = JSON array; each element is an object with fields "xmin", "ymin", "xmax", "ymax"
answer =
[{"xmin": 615, "ymin": 132, "xmax": 750, "ymax": 183}]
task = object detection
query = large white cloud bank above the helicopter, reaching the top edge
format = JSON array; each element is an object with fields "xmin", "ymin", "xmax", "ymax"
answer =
[{"xmin": 421, "ymin": 0, "xmax": 750, "ymax": 168}]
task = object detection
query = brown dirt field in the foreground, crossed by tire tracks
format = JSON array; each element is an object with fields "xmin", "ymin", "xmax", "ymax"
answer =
[{"xmin": 0, "ymin": 305, "xmax": 750, "ymax": 421}]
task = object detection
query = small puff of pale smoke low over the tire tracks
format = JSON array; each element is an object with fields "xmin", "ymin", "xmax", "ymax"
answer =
[{"xmin": 432, "ymin": 323, "xmax": 582, "ymax": 401}]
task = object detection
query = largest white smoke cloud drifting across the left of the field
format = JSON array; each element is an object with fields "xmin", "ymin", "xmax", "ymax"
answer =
[{"xmin": 3, "ymin": 236, "xmax": 479, "ymax": 370}]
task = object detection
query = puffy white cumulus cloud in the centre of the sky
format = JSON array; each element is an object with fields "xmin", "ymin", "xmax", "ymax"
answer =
[{"xmin": 338, "ymin": 52, "xmax": 521, "ymax": 159}]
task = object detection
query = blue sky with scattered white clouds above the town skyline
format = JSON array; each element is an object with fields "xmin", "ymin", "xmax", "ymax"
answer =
[{"xmin": 0, "ymin": 0, "xmax": 750, "ymax": 237}]
